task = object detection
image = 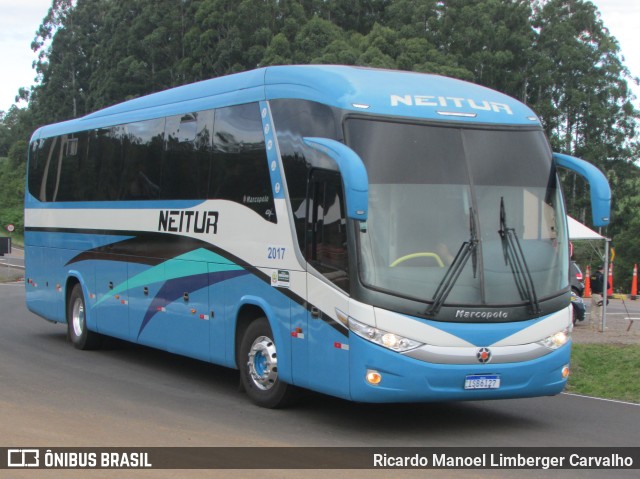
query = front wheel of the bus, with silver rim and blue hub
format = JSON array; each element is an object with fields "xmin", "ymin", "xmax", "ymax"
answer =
[{"xmin": 238, "ymin": 317, "xmax": 295, "ymax": 409}]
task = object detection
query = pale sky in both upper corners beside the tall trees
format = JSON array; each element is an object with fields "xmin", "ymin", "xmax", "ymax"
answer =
[{"xmin": 0, "ymin": 0, "xmax": 640, "ymax": 111}]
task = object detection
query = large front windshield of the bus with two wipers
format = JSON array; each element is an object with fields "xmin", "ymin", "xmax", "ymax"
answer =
[{"xmin": 346, "ymin": 118, "xmax": 569, "ymax": 312}]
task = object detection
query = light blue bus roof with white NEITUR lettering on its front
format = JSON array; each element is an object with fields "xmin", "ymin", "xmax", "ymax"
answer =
[{"xmin": 33, "ymin": 65, "xmax": 540, "ymax": 139}]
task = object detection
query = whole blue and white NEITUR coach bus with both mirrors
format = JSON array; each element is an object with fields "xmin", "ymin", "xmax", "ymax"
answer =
[{"xmin": 25, "ymin": 66, "xmax": 611, "ymax": 408}]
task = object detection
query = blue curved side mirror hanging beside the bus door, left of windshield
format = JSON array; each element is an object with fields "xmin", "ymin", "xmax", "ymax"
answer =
[{"xmin": 303, "ymin": 137, "xmax": 369, "ymax": 221}]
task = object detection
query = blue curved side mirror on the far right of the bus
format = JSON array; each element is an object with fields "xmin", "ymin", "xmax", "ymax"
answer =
[{"xmin": 553, "ymin": 153, "xmax": 611, "ymax": 226}]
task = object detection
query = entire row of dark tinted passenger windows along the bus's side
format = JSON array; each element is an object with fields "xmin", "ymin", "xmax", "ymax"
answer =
[{"xmin": 29, "ymin": 103, "xmax": 276, "ymax": 206}]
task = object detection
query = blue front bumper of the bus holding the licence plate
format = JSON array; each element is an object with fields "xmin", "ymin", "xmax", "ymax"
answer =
[{"xmin": 350, "ymin": 334, "xmax": 571, "ymax": 403}]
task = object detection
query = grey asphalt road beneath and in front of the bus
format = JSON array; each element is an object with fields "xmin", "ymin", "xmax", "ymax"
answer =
[{"xmin": 0, "ymin": 283, "xmax": 640, "ymax": 478}]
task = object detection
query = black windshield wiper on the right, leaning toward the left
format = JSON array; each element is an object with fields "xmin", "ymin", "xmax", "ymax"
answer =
[{"xmin": 498, "ymin": 197, "xmax": 540, "ymax": 314}]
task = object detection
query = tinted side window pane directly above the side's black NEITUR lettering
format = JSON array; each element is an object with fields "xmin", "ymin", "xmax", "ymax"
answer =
[{"xmin": 162, "ymin": 110, "xmax": 214, "ymax": 200}]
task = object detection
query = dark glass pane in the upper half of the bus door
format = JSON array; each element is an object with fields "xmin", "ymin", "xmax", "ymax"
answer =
[{"xmin": 306, "ymin": 170, "xmax": 349, "ymax": 292}]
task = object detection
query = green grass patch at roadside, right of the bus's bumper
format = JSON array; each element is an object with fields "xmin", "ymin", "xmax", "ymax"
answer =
[{"xmin": 565, "ymin": 344, "xmax": 640, "ymax": 403}]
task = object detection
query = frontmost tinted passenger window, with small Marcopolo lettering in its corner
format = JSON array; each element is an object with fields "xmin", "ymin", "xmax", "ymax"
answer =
[{"xmin": 209, "ymin": 103, "xmax": 276, "ymax": 222}]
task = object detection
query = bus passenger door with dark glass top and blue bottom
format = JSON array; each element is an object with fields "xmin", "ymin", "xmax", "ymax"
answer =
[{"xmin": 306, "ymin": 170, "xmax": 349, "ymax": 398}]
